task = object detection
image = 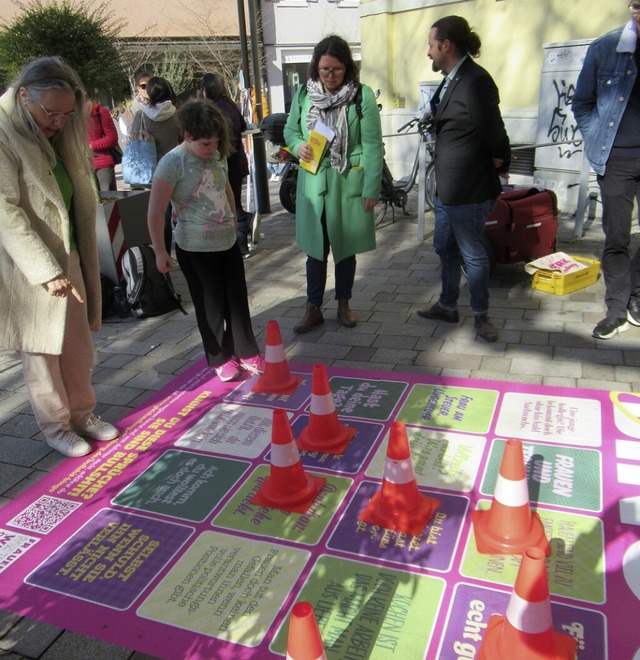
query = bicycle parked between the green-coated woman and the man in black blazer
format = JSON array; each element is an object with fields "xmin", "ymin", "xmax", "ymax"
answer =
[{"xmin": 376, "ymin": 112, "xmax": 436, "ymax": 227}]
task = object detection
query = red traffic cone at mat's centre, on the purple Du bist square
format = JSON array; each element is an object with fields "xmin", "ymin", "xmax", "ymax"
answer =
[{"xmin": 359, "ymin": 422, "xmax": 440, "ymax": 536}]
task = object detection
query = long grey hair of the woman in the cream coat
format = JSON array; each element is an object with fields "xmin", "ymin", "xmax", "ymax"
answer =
[{"xmin": 11, "ymin": 57, "xmax": 90, "ymax": 169}]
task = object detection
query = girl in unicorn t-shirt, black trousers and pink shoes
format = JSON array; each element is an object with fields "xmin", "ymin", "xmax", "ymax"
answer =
[{"xmin": 147, "ymin": 99, "xmax": 264, "ymax": 381}]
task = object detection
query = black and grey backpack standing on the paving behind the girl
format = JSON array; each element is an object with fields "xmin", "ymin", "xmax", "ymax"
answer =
[{"xmin": 122, "ymin": 245, "xmax": 187, "ymax": 319}]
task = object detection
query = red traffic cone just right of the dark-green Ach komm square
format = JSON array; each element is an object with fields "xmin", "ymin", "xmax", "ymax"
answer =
[{"xmin": 251, "ymin": 408, "xmax": 327, "ymax": 513}]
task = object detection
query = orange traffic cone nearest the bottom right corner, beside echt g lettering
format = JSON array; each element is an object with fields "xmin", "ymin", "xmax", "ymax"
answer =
[{"xmin": 477, "ymin": 548, "xmax": 576, "ymax": 660}]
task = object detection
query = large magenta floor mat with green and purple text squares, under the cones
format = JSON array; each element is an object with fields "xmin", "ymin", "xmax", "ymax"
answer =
[{"xmin": 0, "ymin": 363, "xmax": 640, "ymax": 660}]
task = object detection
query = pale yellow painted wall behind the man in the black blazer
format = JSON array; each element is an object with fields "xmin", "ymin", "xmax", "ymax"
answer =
[{"xmin": 360, "ymin": 0, "xmax": 629, "ymax": 109}]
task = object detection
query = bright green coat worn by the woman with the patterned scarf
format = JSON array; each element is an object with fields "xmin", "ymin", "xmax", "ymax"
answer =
[{"xmin": 284, "ymin": 85, "xmax": 384, "ymax": 263}]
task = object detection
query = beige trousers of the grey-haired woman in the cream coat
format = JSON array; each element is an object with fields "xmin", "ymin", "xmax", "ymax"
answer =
[{"xmin": 20, "ymin": 251, "xmax": 96, "ymax": 438}]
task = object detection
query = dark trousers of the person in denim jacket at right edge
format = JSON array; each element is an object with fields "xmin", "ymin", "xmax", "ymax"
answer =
[{"xmin": 598, "ymin": 157, "xmax": 640, "ymax": 318}]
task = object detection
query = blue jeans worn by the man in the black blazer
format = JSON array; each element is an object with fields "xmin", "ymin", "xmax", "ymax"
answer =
[{"xmin": 433, "ymin": 197, "xmax": 495, "ymax": 315}]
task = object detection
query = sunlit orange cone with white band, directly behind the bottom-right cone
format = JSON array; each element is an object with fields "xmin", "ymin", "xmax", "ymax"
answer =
[{"xmin": 471, "ymin": 440, "xmax": 551, "ymax": 555}]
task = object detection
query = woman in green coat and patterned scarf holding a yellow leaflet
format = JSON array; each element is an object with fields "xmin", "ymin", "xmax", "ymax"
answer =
[{"xmin": 284, "ymin": 35, "xmax": 384, "ymax": 334}]
